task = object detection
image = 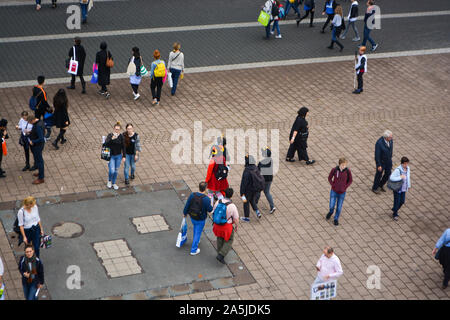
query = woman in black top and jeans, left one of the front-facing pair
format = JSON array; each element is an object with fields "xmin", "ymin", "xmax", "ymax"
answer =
[{"xmin": 105, "ymin": 122, "xmax": 126, "ymax": 190}]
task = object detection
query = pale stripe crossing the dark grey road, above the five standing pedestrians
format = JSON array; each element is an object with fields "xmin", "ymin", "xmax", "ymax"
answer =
[{"xmin": 0, "ymin": 10, "xmax": 450, "ymax": 43}]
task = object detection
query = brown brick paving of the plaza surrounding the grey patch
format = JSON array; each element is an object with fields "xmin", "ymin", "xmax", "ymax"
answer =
[{"xmin": 0, "ymin": 54, "xmax": 450, "ymax": 299}]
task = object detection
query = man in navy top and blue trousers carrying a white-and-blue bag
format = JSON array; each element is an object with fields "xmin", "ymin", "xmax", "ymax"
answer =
[{"xmin": 183, "ymin": 182, "xmax": 213, "ymax": 256}]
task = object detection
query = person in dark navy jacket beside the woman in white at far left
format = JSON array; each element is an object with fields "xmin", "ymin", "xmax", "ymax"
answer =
[{"xmin": 28, "ymin": 117, "xmax": 45, "ymax": 184}]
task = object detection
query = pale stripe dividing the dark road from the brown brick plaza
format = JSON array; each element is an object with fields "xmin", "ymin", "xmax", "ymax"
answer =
[{"xmin": 0, "ymin": 48, "xmax": 450, "ymax": 89}]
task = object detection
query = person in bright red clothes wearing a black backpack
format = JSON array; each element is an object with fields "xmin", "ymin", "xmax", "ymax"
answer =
[{"xmin": 205, "ymin": 145, "xmax": 228, "ymax": 199}]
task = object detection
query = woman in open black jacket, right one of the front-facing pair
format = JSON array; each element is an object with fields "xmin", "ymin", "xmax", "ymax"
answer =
[{"xmin": 123, "ymin": 123, "xmax": 142, "ymax": 185}]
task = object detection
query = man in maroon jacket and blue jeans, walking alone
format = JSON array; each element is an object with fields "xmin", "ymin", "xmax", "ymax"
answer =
[{"xmin": 326, "ymin": 158, "xmax": 353, "ymax": 226}]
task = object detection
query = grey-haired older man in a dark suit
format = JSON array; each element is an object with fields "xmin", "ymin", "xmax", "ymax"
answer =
[{"xmin": 372, "ymin": 130, "xmax": 394, "ymax": 194}]
